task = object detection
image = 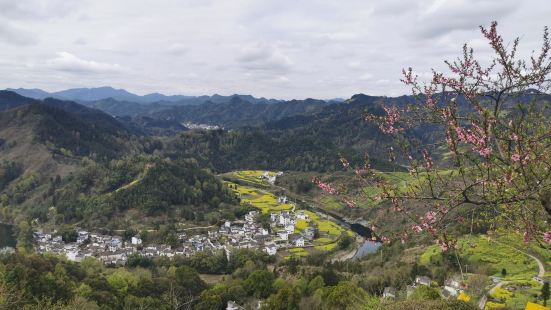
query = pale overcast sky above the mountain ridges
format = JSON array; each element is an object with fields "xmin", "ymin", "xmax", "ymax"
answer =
[{"xmin": 0, "ymin": 0, "xmax": 551, "ymax": 99}]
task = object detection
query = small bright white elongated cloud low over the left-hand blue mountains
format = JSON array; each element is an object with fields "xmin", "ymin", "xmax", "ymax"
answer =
[{"xmin": 48, "ymin": 52, "xmax": 122, "ymax": 74}]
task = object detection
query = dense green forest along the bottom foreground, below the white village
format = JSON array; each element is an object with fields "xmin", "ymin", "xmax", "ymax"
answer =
[{"xmin": 0, "ymin": 243, "xmax": 475, "ymax": 310}]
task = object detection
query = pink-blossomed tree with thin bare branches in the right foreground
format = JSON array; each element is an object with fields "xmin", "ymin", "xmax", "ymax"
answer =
[{"xmin": 315, "ymin": 22, "xmax": 551, "ymax": 251}]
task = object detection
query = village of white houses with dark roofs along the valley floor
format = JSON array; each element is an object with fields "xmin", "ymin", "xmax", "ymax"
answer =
[{"xmin": 34, "ymin": 202, "xmax": 315, "ymax": 265}]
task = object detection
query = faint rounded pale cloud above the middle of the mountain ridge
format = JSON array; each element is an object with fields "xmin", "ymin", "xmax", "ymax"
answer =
[{"xmin": 237, "ymin": 43, "xmax": 293, "ymax": 73}]
